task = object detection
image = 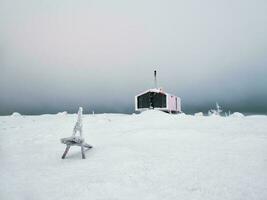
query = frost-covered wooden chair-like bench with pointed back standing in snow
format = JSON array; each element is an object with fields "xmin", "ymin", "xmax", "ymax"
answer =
[{"xmin": 61, "ymin": 107, "xmax": 92, "ymax": 159}]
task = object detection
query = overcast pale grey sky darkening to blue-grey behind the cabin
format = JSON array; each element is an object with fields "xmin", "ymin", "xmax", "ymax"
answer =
[{"xmin": 0, "ymin": 0, "xmax": 267, "ymax": 115}]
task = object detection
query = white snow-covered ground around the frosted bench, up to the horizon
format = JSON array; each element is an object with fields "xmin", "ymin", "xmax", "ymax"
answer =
[{"xmin": 0, "ymin": 111, "xmax": 267, "ymax": 200}]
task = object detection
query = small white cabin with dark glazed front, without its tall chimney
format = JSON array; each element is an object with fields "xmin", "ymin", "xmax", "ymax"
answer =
[{"xmin": 135, "ymin": 88, "xmax": 182, "ymax": 113}]
